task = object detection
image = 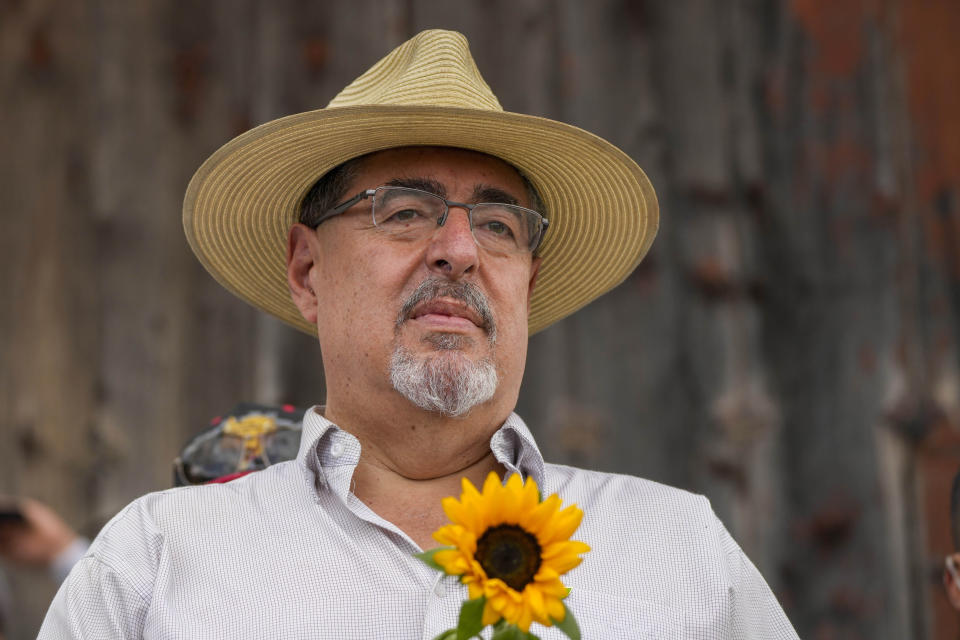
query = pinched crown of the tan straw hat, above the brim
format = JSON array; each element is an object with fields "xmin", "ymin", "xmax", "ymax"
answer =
[{"xmin": 327, "ymin": 29, "xmax": 503, "ymax": 111}]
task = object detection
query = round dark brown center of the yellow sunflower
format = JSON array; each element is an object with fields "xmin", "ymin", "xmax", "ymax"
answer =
[{"xmin": 476, "ymin": 524, "xmax": 540, "ymax": 591}]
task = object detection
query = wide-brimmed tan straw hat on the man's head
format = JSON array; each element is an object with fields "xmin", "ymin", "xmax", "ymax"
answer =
[{"xmin": 183, "ymin": 30, "xmax": 658, "ymax": 334}]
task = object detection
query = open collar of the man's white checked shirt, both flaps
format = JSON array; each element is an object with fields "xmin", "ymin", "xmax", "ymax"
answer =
[{"xmin": 297, "ymin": 405, "xmax": 544, "ymax": 494}]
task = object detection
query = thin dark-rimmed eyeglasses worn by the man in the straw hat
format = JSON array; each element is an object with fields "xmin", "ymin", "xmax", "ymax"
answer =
[{"xmin": 314, "ymin": 186, "xmax": 549, "ymax": 254}]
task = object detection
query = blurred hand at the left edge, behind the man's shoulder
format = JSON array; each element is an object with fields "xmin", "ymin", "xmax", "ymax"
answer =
[{"xmin": 0, "ymin": 498, "xmax": 77, "ymax": 568}]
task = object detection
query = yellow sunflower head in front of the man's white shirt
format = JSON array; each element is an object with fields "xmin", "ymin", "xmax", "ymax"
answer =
[{"xmin": 431, "ymin": 472, "xmax": 590, "ymax": 632}]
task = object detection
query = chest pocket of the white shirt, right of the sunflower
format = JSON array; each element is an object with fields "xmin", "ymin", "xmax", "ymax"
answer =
[{"xmin": 564, "ymin": 588, "xmax": 683, "ymax": 640}]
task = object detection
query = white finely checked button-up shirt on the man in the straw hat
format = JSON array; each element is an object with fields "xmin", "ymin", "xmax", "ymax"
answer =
[{"xmin": 39, "ymin": 409, "xmax": 797, "ymax": 640}]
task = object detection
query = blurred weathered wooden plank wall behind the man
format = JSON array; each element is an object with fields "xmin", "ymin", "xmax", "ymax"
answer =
[{"xmin": 0, "ymin": 0, "xmax": 960, "ymax": 640}]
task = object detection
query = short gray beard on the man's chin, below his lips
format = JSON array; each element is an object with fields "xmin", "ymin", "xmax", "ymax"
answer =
[{"xmin": 390, "ymin": 342, "xmax": 499, "ymax": 417}]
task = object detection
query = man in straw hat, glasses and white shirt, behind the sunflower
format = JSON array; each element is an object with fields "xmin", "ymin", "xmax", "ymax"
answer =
[{"xmin": 41, "ymin": 31, "xmax": 796, "ymax": 639}]
